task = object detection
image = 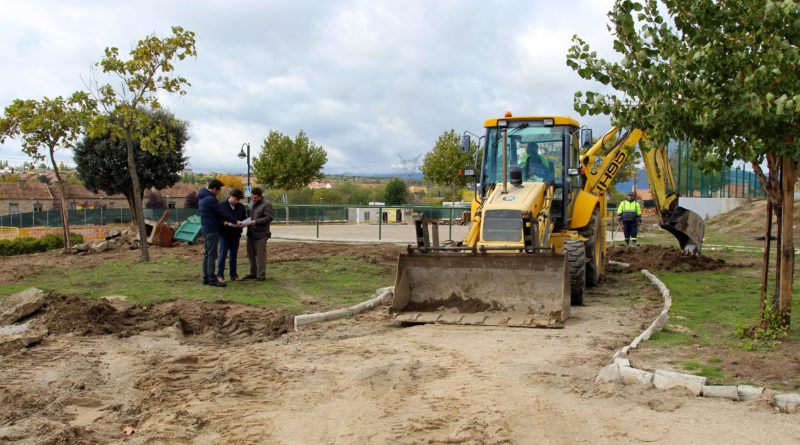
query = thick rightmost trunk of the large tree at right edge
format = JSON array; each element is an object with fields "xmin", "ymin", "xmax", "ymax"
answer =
[{"xmin": 780, "ymin": 156, "xmax": 796, "ymax": 327}]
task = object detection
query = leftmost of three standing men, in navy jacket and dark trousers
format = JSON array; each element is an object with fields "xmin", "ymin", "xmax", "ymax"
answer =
[{"xmin": 197, "ymin": 179, "xmax": 242, "ymax": 287}]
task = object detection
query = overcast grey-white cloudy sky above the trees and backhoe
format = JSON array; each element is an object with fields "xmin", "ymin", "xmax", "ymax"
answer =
[{"xmin": 0, "ymin": 0, "xmax": 614, "ymax": 174}]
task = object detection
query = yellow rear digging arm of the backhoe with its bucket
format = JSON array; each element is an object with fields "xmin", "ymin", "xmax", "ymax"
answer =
[{"xmin": 580, "ymin": 127, "xmax": 705, "ymax": 255}]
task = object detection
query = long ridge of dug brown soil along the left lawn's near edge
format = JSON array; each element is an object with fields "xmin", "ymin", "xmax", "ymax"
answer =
[{"xmin": 33, "ymin": 294, "xmax": 293, "ymax": 343}]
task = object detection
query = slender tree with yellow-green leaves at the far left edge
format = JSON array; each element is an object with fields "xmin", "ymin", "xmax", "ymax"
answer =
[{"xmin": 0, "ymin": 91, "xmax": 95, "ymax": 250}]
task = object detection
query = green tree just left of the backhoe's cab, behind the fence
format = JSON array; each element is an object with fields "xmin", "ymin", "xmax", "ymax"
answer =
[{"xmin": 420, "ymin": 130, "xmax": 480, "ymax": 200}]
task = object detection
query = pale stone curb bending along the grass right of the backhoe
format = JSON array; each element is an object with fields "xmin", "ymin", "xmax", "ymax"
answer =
[{"xmin": 595, "ymin": 268, "xmax": 800, "ymax": 413}]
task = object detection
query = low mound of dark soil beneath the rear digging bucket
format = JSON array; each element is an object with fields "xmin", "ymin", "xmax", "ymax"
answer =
[{"xmin": 608, "ymin": 245, "xmax": 729, "ymax": 273}]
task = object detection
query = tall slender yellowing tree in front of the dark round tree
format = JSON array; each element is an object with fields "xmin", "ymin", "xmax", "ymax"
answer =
[{"xmin": 91, "ymin": 26, "xmax": 197, "ymax": 261}]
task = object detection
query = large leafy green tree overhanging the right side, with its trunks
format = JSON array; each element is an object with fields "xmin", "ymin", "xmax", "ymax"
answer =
[{"xmin": 567, "ymin": 0, "xmax": 800, "ymax": 326}]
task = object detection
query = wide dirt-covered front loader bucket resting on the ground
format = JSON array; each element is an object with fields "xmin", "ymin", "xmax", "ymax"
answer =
[{"xmin": 392, "ymin": 253, "xmax": 570, "ymax": 327}]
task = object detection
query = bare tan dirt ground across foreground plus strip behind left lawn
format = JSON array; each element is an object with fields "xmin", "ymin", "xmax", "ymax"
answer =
[{"xmin": 0, "ymin": 243, "xmax": 800, "ymax": 444}]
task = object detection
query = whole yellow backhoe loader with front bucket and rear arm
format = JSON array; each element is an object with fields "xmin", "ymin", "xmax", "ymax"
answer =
[{"xmin": 392, "ymin": 113, "xmax": 704, "ymax": 327}]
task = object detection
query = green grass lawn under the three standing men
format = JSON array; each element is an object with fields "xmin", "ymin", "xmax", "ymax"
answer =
[{"xmin": 0, "ymin": 256, "xmax": 394, "ymax": 313}]
